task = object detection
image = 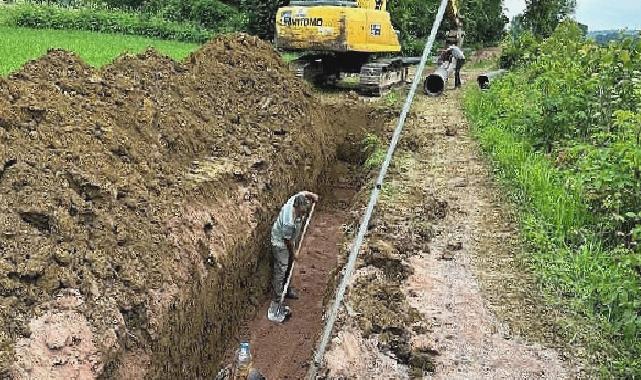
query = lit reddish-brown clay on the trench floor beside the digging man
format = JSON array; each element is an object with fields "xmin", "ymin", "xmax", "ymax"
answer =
[{"xmin": 242, "ymin": 192, "xmax": 353, "ymax": 379}]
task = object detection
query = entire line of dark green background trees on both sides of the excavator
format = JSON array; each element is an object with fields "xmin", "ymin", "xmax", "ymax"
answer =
[{"xmin": 12, "ymin": 0, "xmax": 576, "ymax": 55}]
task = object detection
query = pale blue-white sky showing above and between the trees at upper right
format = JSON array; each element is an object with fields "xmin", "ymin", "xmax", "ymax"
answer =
[{"xmin": 503, "ymin": 0, "xmax": 641, "ymax": 30}]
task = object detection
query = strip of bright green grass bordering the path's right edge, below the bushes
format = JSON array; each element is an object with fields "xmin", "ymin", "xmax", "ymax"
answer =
[{"xmin": 465, "ymin": 82, "xmax": 641, "ymax": 378}]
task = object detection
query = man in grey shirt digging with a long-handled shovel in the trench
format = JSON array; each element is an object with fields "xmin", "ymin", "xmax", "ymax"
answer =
[{"xmin": 268, "ymin": 191, "xmax": 318, "ymax": 319}]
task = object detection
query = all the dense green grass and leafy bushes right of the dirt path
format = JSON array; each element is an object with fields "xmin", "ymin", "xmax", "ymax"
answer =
[{"xmin": 466, "ymin": 22, "xmax": 641, "ymax": 378}]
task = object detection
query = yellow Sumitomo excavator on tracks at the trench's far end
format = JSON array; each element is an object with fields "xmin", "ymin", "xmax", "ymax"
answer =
[{"xmin": 275, "ymin": 0, "xmax": 465, "ymax": 95}]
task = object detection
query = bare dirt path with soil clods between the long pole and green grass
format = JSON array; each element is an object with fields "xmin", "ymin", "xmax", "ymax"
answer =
[{"xmin": 325, "ymin": 70, "xmax": 576, "ymax": 379}]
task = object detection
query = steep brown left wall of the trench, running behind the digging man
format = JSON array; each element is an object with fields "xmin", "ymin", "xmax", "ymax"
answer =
[{"xmin": 145, "ymin": 101, "xmax": 383, "ymax": 378}]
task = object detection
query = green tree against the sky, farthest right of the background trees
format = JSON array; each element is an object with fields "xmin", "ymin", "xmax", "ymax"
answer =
[{"xmin": 518, "ymin": 0, "xmax": 576, "ymax": 38}]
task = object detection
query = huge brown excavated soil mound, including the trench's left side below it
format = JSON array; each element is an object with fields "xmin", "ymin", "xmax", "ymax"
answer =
[{"xmin": 0, "ymin": 35, "xmax": 360, "ymax": 378}]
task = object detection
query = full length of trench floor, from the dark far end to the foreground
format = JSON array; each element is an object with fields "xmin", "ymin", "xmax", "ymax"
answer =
[{"xmin": 221, "ymin": 115, "xmax": 380, "ymax": 379}]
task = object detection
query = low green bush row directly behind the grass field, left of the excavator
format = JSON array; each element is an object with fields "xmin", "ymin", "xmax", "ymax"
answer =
[{"xmin": 15, "ymin": 6, "xmax": 213, "ymax": 43}]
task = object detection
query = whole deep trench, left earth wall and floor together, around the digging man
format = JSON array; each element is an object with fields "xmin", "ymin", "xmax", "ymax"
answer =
[{"xmin": 128, "ymin": 103, "xmax": 392, "ymax": 379}]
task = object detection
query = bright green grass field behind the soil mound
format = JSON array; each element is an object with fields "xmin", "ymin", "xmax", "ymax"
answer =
[{"xmin": 0, "ymin": 26, "xmax": 199, "ymax": 75}]
